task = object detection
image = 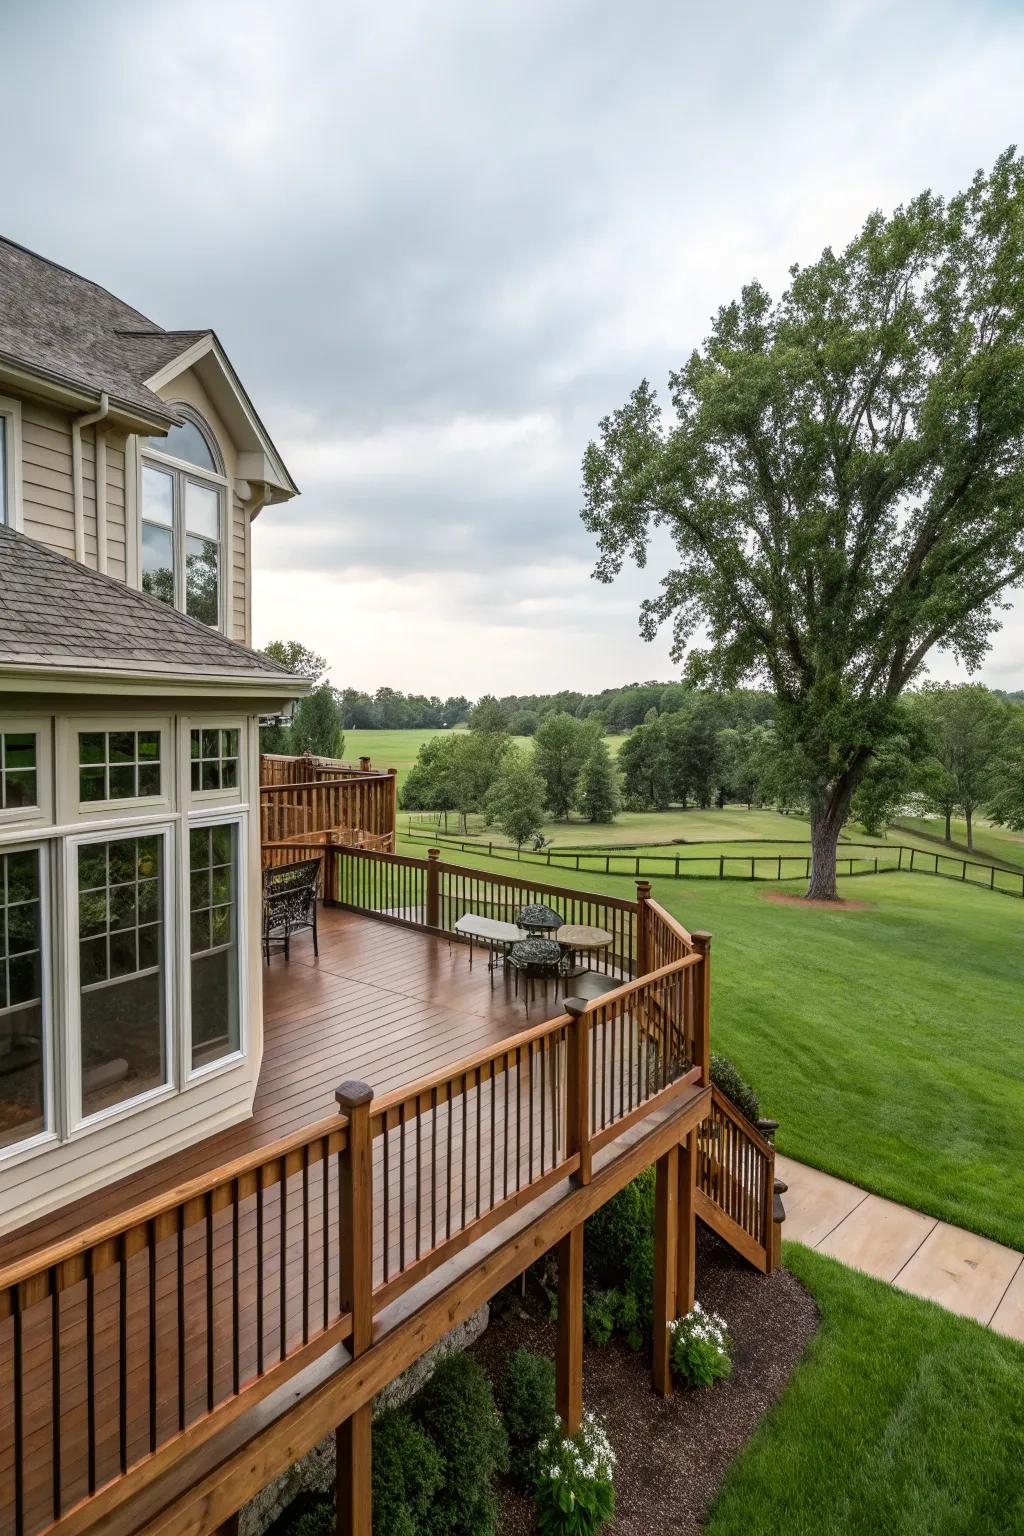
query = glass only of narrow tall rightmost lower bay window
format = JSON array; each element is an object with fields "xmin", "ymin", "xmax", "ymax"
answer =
[{"xmin": 189, "ymin": 825, "xmax": 241, "ymax": 1068}]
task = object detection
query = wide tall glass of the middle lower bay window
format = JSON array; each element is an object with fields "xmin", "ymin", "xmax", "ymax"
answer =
[{"xmin": 78, "ymin": 841, "xmax": 167, "ymax": 1115}]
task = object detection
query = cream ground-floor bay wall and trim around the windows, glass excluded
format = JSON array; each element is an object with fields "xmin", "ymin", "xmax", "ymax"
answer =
[{"xmin": 0, "ymin": 693, "xmax": 263, "ymax": 1232}]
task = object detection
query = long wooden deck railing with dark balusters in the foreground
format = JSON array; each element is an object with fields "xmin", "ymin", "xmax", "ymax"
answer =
[{"xmin": 0, "ymin": 952, "xmax": 708, "ymax": 1536}]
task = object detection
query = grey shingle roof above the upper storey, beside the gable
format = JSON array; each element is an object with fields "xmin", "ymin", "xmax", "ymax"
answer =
[{"xmin": 0, "ymin": 237, "xmax": 209, "ymax": 424}]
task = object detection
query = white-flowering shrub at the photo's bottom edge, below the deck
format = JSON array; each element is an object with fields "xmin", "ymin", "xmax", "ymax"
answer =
[{"xmin": 536, "ymin": 1413, "xmax": 616, "ymax": 1536}]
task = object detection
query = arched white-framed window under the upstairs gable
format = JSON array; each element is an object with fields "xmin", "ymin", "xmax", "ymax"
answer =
[{"xmin": 141, "ymin": 404, "xmax": 227, "ymax": 628}]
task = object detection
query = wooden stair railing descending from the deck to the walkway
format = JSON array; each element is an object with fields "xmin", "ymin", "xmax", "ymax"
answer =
[{"xmin": 697, "ymin": 1087, "xmax": 775, "ymax": 1273}]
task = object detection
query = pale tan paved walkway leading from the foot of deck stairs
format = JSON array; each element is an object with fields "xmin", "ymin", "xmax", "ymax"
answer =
[{"xmin": 775, "ymin": 1154, "xmax": 1024, "ymax": 1341}]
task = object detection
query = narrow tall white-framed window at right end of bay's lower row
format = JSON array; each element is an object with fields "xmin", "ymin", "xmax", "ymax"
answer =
[{"xmin": 184, "ymin": 817, "xmax": 246, "ymax": 1077}]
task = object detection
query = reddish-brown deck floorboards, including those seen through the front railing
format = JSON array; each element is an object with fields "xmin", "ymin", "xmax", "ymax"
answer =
[{"xmin": 0, "ymin": 909, "xmax": 589, "ymax": 1531}]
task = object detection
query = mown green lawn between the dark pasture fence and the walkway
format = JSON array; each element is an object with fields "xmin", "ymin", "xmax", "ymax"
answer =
[{"xmin": 399, "ymin": 843, "xmax": 1024, "ymax": 1247}]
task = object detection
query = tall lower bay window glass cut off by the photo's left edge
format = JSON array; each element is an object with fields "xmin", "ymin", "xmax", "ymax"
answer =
[{"xmin": 0, "ymin": 851, "xmax": 46, "ymax": 1147}]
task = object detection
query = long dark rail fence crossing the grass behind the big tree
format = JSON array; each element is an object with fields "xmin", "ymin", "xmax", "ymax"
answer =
[{"xmin": 399, "ymin": 836, "xmax": 1024, "ymax": 897}]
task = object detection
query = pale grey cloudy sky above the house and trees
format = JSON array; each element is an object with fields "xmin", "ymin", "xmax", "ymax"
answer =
[{"xmin": 0, "ymin": 0, "xmax": 1024, "ymax": 694}]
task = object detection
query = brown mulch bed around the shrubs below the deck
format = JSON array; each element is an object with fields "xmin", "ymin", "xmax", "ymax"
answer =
[{"xmin": 473, "ymin": 1229, "xmax": 818, "ymax": 1536}]
